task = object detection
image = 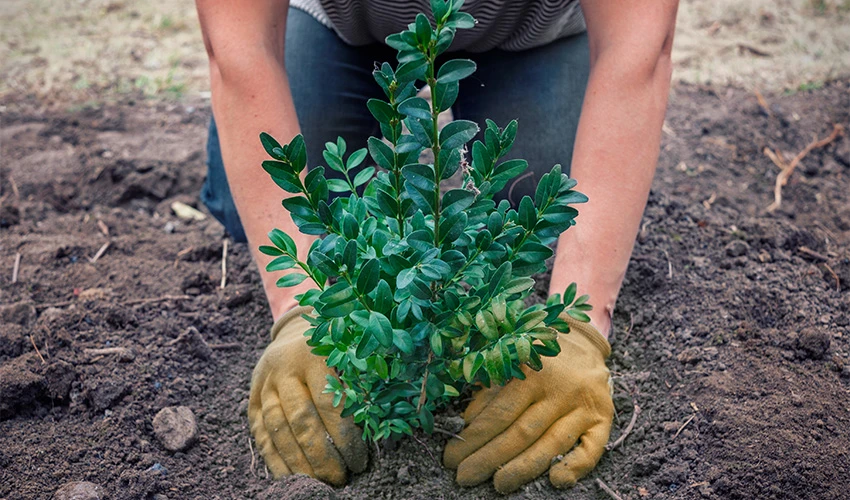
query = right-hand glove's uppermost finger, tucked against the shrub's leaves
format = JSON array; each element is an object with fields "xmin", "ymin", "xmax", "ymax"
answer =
[{"xmin": 443, "ymin": 384, "xmax": 532, "ymax": 470}]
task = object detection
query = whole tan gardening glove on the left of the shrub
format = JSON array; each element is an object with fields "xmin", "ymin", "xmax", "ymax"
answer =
[{"xmin": 248, "ymin": 307, "xmax": 368, "ymax": 486}]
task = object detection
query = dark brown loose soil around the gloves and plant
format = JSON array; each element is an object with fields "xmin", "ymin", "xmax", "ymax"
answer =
[{"xmin": 0, "ymin": 81, "xmax": 850, "ymax": 499}]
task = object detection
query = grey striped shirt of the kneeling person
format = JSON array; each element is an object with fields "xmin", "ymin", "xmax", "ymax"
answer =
[{"xmin": 290, "ymin": 0, "xmax": 586, "ymax": 52}]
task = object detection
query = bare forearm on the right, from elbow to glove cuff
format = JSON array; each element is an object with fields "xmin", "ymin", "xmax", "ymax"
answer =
[{"xmin": 550, "ymin": 50, "xmax": 670, "ymax": 336}]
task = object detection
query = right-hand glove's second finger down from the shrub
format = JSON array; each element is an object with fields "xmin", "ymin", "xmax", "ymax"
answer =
[{"xmin": 450, "ymin": 403, "xmax": 559, "ymax": 486}]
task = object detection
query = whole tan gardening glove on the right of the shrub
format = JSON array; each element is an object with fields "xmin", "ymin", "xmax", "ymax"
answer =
[{"xmin": 443, "ymin": 315, "xmax": 614, "ymax": 493}]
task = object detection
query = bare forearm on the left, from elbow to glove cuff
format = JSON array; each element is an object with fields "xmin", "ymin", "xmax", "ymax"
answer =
[{"xmin": 211, "ymin": 61, "xmax": 312, "ymax": 319}]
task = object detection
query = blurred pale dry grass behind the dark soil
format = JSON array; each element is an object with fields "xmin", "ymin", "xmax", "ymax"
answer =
[{"xmin": 0, "ymin": 0, "xmax": 850, "ymax": 104}]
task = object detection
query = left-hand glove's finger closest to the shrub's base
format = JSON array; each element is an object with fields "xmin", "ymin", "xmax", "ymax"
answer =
[{"xmin": 308, "ymin": 370, "xmax": 369, "ymax": 472}]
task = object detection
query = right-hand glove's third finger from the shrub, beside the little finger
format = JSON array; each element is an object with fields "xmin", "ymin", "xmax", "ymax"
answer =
[{"xmin": 486, "ymin": 412, "xmax": 586, "ymax": 493}]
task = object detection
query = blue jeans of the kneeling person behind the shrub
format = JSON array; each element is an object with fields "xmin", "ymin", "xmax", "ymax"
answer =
[{"xmin": 201, "ymin": 9, "xmax": 590, "ymax": 241}]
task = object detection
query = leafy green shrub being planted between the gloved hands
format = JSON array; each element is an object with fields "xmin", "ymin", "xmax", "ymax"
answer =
[{"xmin": 260, "ymin": 0, "xmax": 590, "ymax": 441}]
